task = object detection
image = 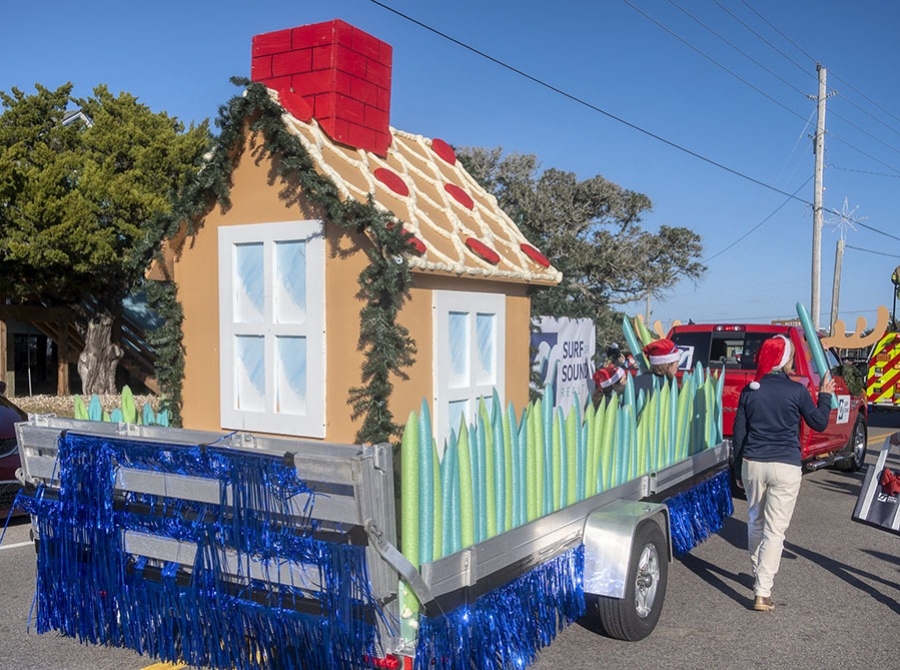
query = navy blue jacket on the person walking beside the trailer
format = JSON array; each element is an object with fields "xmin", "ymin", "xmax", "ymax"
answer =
[{"xmin": 732, "ymin": 371, "xmax": 831, "ymax": 477}]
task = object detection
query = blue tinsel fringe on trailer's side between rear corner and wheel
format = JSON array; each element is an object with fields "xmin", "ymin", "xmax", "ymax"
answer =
[{"xmin": 416, "ymin": 545, "xmax": 585, "ymax": 670}]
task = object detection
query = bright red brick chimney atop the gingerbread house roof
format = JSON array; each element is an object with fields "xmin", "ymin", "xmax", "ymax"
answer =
[{"xmin": 251, "ymin": 19, "xmax": 392, "ymax": 156}]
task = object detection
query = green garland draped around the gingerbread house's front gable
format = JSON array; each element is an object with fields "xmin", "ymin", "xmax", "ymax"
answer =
[{"xmin": 158, "ymin": 78, "xmax": 416, "ymax": 444}]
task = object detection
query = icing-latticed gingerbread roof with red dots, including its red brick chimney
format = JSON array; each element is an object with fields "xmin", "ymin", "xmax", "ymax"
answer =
[{"xmin": 252, "ymin": 20, "xmax": 562, "ymax": 284}]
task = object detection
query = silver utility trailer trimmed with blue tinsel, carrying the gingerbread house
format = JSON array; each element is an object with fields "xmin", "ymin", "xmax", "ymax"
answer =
[{"xmin": 17, "ymin": 416, "xmax": 732, "ymax": 670}]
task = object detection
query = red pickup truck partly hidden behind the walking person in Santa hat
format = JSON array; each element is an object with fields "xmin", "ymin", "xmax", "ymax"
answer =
[{"xmin": 669, "ymin": 324, "xmax": 867, "ymax": 472}]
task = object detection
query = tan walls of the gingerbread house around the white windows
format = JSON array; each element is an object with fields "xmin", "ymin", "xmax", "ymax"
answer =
[{"xmin": 174, "ymin": 134, "xmax": 530, "ymax": 443}]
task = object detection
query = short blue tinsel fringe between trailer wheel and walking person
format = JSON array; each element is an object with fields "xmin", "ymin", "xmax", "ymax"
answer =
[{"xmin": 665, "ymin": 470, "xmax": 734, "ymax": 556}]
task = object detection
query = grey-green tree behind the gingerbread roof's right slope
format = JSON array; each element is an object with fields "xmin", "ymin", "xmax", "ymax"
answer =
[{"xmin": 456, "ymin": 147, "xmax": 706, "ymax": 342}]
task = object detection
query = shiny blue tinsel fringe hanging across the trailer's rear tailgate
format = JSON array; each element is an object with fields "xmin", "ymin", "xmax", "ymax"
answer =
[{"xmin": 19, "ymin": 435, "xmax": 378, "ymax": 670}]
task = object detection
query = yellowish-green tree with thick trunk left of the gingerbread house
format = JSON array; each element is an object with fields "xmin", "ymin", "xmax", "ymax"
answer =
[{"xmin": 0, "ymin": 84, "xmax": 210, "ymax": 393}]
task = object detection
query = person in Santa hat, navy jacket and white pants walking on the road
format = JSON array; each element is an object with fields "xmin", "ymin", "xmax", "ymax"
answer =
[{"xmin": 732, "ymin": 335, "xmax": 834, "ymax": 612}]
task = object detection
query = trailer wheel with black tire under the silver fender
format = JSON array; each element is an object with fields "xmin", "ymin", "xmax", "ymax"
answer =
[{"xmin": 597, "ymin": 521, "xmax": 669, "ymax": 641}]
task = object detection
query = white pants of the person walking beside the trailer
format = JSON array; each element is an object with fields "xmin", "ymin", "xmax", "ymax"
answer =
[{"xmin": 741, "ymin": 459, "xmax": 803, "ymax": 596}]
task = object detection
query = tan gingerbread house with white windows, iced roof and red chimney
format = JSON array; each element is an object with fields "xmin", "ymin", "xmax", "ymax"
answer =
[{"xmin": 163, "ymin": 20, "xmax": 560, "ymax": 443}]
